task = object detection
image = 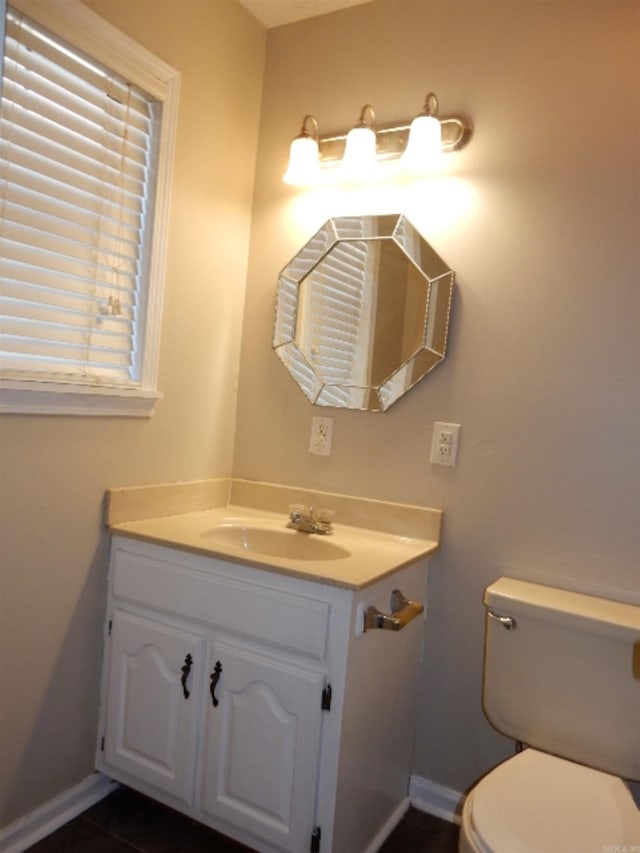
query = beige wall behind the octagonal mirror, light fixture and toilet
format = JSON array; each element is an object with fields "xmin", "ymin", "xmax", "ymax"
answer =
[{"xmin": 234, "ymin": 0, "xmax": 640, "ymax": 790}]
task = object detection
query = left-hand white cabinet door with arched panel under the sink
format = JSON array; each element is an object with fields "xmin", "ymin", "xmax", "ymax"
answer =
[{"xmin": 104, "ymin": 610, "xmax": 206, "ymax": 803}]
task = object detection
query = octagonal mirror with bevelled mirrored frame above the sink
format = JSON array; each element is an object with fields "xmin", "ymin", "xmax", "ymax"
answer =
[{"xmin": 273, "ymin": 214, "xmax": 454, "ymax": 412}]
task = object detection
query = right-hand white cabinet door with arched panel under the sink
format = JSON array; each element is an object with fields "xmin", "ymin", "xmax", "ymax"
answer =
[{"xmin": 201, "ymin": 641, "xmax": 325, "ymax": 853}]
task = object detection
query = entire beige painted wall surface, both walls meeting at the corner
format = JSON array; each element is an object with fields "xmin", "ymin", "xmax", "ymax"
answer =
[{"xmin": 0, "ymin": 0, "xmax": 640, "ymax": 825}]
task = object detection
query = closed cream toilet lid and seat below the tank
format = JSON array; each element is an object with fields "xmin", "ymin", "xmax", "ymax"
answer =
[{"xmin": 463, "ymin": 749, "xmax": 640, "ymax": 853}]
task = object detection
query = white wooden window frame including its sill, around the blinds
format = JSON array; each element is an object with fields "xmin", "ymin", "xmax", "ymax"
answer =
[{"xmin": 0, "ymin": 0, "xmax": 180, "ymax": 417}]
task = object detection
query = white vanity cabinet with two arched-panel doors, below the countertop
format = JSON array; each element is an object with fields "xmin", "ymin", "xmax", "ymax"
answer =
[{"xmin": 97, "ymin": 534, "xmax": 427, "ymax": 853}]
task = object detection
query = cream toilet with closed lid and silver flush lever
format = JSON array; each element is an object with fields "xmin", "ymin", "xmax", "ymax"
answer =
[{"xmin": 459, "ymin": 578, "xmax": 640, "ymax": 853}]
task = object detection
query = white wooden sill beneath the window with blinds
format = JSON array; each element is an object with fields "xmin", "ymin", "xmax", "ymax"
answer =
[{"xmin": 0, "ymin": 380, "xmax": 162, "ymax": 418}]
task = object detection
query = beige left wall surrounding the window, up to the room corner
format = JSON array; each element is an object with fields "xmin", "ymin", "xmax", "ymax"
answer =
[{"xmin": 0, "ymin": 0, "xmax": 266, "ymax": 825}]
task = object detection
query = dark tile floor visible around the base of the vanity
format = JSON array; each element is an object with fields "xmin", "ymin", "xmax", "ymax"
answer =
[{"xmin": 29, "ymin": 788, "xmax": 458, "ymax": 853}]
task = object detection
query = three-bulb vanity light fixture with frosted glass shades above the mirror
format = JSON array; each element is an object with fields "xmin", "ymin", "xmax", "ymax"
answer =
[{"xmin": 283, "ymin": 92, "xmax": 473, "ymax": 186}]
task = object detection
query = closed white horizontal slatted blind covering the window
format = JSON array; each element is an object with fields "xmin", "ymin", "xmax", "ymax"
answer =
[{"xmin": 0, "ymin": 8, "xmax": 160, "ymax": 387}]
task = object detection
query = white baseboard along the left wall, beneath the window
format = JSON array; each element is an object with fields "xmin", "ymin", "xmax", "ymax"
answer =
[{"xmin": 0, "ymin": 773, "xmax": 118, "ymax": 853}]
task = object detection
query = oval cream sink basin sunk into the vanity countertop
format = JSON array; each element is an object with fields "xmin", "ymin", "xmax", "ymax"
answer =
[{"xmin": 203, "ymin": 522, "xmax": 351, "ymax": 560}]
